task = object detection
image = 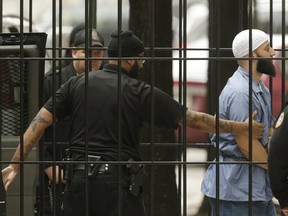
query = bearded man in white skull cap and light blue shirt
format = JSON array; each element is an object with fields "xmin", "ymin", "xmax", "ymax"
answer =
[{"xmin": 201, "ymin": 29, "xmax": 275, "ymax": 216}]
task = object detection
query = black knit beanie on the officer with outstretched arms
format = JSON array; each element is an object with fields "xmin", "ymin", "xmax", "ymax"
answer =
[{"xmin": 108, "ymin": 30, "xmax": 144, "ymax": 57}]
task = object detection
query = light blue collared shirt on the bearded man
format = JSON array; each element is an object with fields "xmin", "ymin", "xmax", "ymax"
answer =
[{"xmin": 201, "ymin": 66, "xmax": 275, "ymax": 201}]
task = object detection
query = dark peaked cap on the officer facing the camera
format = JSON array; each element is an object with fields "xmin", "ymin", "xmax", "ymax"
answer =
[{"xmin": 74, "ymin": 29, "xmax": 104, "ymax": 47}]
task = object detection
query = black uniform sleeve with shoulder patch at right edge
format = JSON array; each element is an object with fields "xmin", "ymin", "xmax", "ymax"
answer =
[{"xmin": 268, "ymin": 106, "xmax": 288, "ymax": 208}]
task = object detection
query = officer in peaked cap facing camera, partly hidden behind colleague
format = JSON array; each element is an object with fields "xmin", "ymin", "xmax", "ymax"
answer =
[{"xmin": 34, "ymin": 27, "xmax": 105, "ymax": 216}]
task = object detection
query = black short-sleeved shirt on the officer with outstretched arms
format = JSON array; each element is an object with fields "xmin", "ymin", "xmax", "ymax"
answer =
[{"xmin": 44, "ymin": 64, "xmax": 183, "ymax": 160}]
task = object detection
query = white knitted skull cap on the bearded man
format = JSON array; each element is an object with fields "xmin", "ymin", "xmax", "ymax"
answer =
[{"xmin": 232, "ymin": 29, "xmax": 268, "ymax": 58}]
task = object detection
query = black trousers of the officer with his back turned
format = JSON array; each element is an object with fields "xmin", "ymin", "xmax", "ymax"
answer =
[{"xmin": 64, "ymin": 171, "xmax": 145, "ymax": 216}]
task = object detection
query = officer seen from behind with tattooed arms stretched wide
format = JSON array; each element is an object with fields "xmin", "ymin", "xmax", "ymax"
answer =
[{"xmin": 2, "ymin": 31, "xmax": 263, "ymax": 216}]
